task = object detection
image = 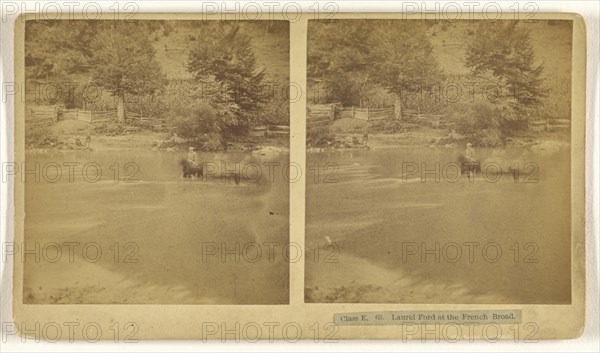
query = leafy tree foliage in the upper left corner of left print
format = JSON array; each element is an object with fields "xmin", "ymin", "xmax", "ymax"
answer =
[{"xmin": 25, "ymin": 20, "xmax": 164, "ymax": 120}]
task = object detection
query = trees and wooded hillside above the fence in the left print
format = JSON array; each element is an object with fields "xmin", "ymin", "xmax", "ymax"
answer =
[{"xmin": 25, "ymin": 21, "xmax": 289, "ymax": 144}]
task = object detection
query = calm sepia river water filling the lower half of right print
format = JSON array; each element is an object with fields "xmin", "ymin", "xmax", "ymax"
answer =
[{"xmin": 305, "ymin": 148, "xmax": 571, "ymax": 303}]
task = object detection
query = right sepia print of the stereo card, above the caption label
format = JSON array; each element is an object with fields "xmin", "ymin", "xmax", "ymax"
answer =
[{"xmin": 305, "ymin": 19, "xmax": 573, "ymax": 304}]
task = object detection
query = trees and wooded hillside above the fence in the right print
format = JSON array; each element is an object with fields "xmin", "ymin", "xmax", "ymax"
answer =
[{"xmin": 308, "ymin": 20, "xmax": 571, "ymax": 144}]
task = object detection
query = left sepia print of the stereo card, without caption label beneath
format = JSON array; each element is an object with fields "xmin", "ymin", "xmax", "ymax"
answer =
[{"xmin": 23, "ymin": 19, "xmax": 290, "ymax": 304}]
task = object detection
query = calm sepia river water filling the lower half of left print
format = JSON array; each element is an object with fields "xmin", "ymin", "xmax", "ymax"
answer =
[{"xmin": 24, "ymin": 151, "xmax": 289, "ymax": 304}]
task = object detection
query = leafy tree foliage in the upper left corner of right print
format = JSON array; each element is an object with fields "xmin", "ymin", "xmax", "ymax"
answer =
[{"xmin": 308, "ymin": 20, "xmax": 441, "ymax": 108}]
